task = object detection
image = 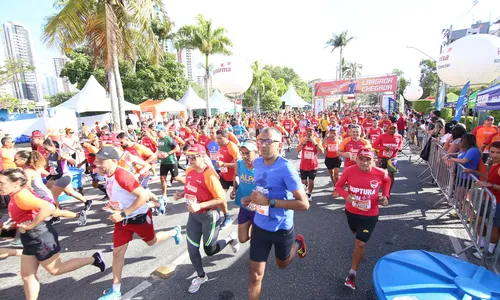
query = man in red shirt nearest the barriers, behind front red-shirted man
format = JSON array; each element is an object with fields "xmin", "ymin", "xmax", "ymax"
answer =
[{"xmin": 373, "ymin": 124, "xmax": 403, "ymax": 193}]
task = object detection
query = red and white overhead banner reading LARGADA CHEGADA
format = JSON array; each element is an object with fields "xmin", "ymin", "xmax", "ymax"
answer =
[{"xmin": 314, "ymin": 75, "xmax": 398, "ymax": 97}]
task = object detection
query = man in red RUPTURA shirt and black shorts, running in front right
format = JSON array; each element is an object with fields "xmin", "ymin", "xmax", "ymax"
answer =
[{"xmin": 335, "ymin": 149, "xmax": 391, "ymax": 290}]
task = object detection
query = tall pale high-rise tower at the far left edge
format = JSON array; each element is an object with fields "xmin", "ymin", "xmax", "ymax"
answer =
[{"xmin": 0, "ymin": 22, "xmax": 42, "ymax": 101}]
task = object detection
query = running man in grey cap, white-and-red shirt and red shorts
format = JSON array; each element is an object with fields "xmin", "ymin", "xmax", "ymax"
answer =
[{"xmin": 95, "ymin": 146, "xmax": 182, "ymax": 300}]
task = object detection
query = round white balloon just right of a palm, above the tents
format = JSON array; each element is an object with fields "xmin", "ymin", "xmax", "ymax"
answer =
[{"xmin": 212, "ymin": 57, "xmax": 253, "ymax": 94}]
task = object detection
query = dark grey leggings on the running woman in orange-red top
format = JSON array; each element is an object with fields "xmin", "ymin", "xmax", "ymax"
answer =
[{"xmin": 186, "ymin": 210, "xmax": 228, "ymax": 277}]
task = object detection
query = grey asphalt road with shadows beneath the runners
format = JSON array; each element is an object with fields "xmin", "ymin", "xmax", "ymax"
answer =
[{"xmin": 0, "ymin": 144, "xmax": 474, "ymax": 300}]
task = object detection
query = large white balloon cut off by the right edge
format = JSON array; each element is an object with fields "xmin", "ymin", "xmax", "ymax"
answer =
[{"xmin": 437, "ymin": 34, "xmax": 500, "ymax": 86}]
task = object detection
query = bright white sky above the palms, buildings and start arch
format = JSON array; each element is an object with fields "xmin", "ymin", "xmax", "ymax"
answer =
[{"xmin": 0, "ymin": 0, "xmax": 500, "ymax": 84}]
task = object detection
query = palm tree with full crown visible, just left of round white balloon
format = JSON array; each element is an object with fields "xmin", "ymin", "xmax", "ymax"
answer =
[{"xmin": 175, "ymin": 14, "xmax": 233, "ymax": 117}]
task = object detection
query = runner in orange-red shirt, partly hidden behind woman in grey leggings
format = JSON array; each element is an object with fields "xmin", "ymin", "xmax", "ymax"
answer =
[{"xmin": 215, "ymin": 129, "xmax": 239, "ymax": 228}]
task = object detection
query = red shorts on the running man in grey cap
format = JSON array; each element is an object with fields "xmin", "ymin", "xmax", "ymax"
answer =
[{"xmin": 113, "ymin": 210, "xmax": 156, "ymax": 248}]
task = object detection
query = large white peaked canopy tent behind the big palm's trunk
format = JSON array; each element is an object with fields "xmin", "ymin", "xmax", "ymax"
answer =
[{"xmin": 56, "ymin": 75, "xmax": 140, "ymax": 113}]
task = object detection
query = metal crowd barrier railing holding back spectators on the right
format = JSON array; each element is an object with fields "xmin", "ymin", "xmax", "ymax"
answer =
[{"xmin": 419, "ymin": 135, "xmax": 500, "ymax": 274}]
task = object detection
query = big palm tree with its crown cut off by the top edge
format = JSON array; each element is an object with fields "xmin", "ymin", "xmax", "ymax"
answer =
[{"xmin": 42, "ymin": 0, "xmax": 168, "ymax": 128}]
